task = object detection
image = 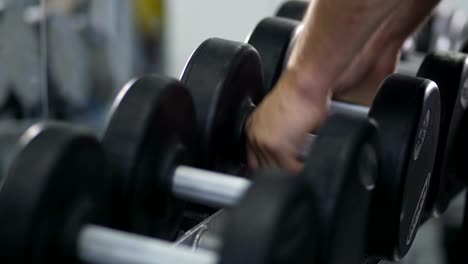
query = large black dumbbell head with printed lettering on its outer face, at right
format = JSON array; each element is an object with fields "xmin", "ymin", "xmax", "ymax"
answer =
[{"xmin": 369, "ymin": 74, "xmax": 440, "ymax": 260}]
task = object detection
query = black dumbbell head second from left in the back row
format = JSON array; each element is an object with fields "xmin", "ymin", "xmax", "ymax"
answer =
[{"xmin": 102, "ymin": 76, "xmax": 197, "ymax": 239}]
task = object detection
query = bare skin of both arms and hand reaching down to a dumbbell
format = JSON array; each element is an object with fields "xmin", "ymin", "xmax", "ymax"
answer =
[{"xmin": 246, "ymin": 0, "xmax": 439, "ymax": 173}]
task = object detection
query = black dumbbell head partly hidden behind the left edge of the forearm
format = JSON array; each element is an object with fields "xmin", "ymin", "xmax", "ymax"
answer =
[{"xmin": 247, "ymin": 17, "xmax": 299, "ymax": 94}]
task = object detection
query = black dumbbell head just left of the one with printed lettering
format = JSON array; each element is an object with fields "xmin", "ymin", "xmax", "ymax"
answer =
[{"xmin": 303, "ymin": 114, "xmax": 380, "ymax": 264}]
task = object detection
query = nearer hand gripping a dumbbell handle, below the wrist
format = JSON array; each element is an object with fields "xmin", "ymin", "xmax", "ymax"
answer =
[{"xmin": 245, "ymin": 69, "xmax": 331, "ymax": 173}]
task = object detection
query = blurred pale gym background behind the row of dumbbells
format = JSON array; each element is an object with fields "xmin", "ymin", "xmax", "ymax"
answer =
[{"xmin": 0, "ymin": 0, "xmax": 468, "ymax": 264}]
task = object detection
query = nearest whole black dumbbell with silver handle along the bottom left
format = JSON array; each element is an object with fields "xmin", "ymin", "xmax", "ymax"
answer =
[{"xmin": 0, "ymin": 123, "xmax": 318, "ymax": 264}]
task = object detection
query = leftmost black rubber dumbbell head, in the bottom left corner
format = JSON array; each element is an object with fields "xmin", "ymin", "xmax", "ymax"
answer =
[{"xmin": 0, "ymin": 123, "xmax": 110, "ymax": 263}]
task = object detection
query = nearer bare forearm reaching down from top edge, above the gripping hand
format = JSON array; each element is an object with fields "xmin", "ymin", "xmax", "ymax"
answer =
[{"xmin": 288, "ymin": 0, "xmax": 404, "ymax": 96}]
